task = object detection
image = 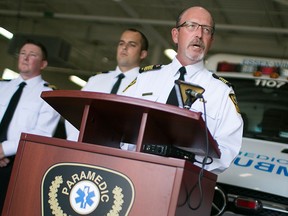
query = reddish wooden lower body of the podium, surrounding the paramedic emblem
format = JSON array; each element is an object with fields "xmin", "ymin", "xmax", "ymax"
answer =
[{"xmin": 3, "ymin": 134, "xmax": 216, "ymax": 216}]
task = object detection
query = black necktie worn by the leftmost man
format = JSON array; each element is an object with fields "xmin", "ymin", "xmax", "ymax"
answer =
[{"xmin": 0, "ymin": 82, "xmax": 26, "ymax": 142}]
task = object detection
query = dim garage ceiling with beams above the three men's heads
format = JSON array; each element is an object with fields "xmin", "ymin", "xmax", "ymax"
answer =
[{"xmin": 0, "ymin": 0, "xmax": 288, "ymax": 89}]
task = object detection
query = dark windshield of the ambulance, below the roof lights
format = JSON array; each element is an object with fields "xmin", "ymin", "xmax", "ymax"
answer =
[{"xmin": 225, "ymin": 77, "xmax": 288, "ymax": 144}]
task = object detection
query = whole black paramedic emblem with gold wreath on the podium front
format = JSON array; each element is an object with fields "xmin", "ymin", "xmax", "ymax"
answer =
[{"xmin": 41, "ymin": 163, "xmax": 135, "ymax": 216}]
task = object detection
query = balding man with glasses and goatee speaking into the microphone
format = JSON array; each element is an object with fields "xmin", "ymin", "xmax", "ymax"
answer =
[{"xmin": 127, "ymin": 7, "xmax": 243, "ymax": 174}]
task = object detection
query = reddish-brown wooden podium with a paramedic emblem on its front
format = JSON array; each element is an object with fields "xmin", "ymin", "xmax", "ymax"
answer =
[{"xmin": 3, "ymin": 90, "xmax": 220, "ymax": 216}]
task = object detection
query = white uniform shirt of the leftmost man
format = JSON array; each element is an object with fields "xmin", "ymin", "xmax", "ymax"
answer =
[{"xmin": 0, "ymin": 76, "xmax": 60, "ymax": 156}]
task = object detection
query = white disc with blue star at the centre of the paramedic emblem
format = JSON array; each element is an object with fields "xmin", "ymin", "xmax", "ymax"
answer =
[{"xmin": 70, "ymin": 181, "xmax": 100, "ymax": 215}]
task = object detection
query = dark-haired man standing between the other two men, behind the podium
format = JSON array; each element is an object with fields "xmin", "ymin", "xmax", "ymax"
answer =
[{"xmin": 65, "ymin": 29, "xmax": 149, "ymax": 141}]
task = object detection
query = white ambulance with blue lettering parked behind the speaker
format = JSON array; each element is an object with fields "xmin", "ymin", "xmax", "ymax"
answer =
[{"xmin": 205, "ymin": 54, "xmax": 288, "ymax": 216}]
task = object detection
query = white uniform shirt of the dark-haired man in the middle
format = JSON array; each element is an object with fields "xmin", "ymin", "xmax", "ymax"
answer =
[{"xmin": 65, "ymin": 66, "xmax": 140, "ymax": 141}]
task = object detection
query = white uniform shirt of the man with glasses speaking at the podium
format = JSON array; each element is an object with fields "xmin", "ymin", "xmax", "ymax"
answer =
[{"xmin": 126, "ymin": 58, "xmax": 243, "ymax": 174}]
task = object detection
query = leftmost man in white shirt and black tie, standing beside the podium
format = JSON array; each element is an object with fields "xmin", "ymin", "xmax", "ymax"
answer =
[{"xmin": 0, "ymin": 41, "xmax": 60, "ymax": 212}]
